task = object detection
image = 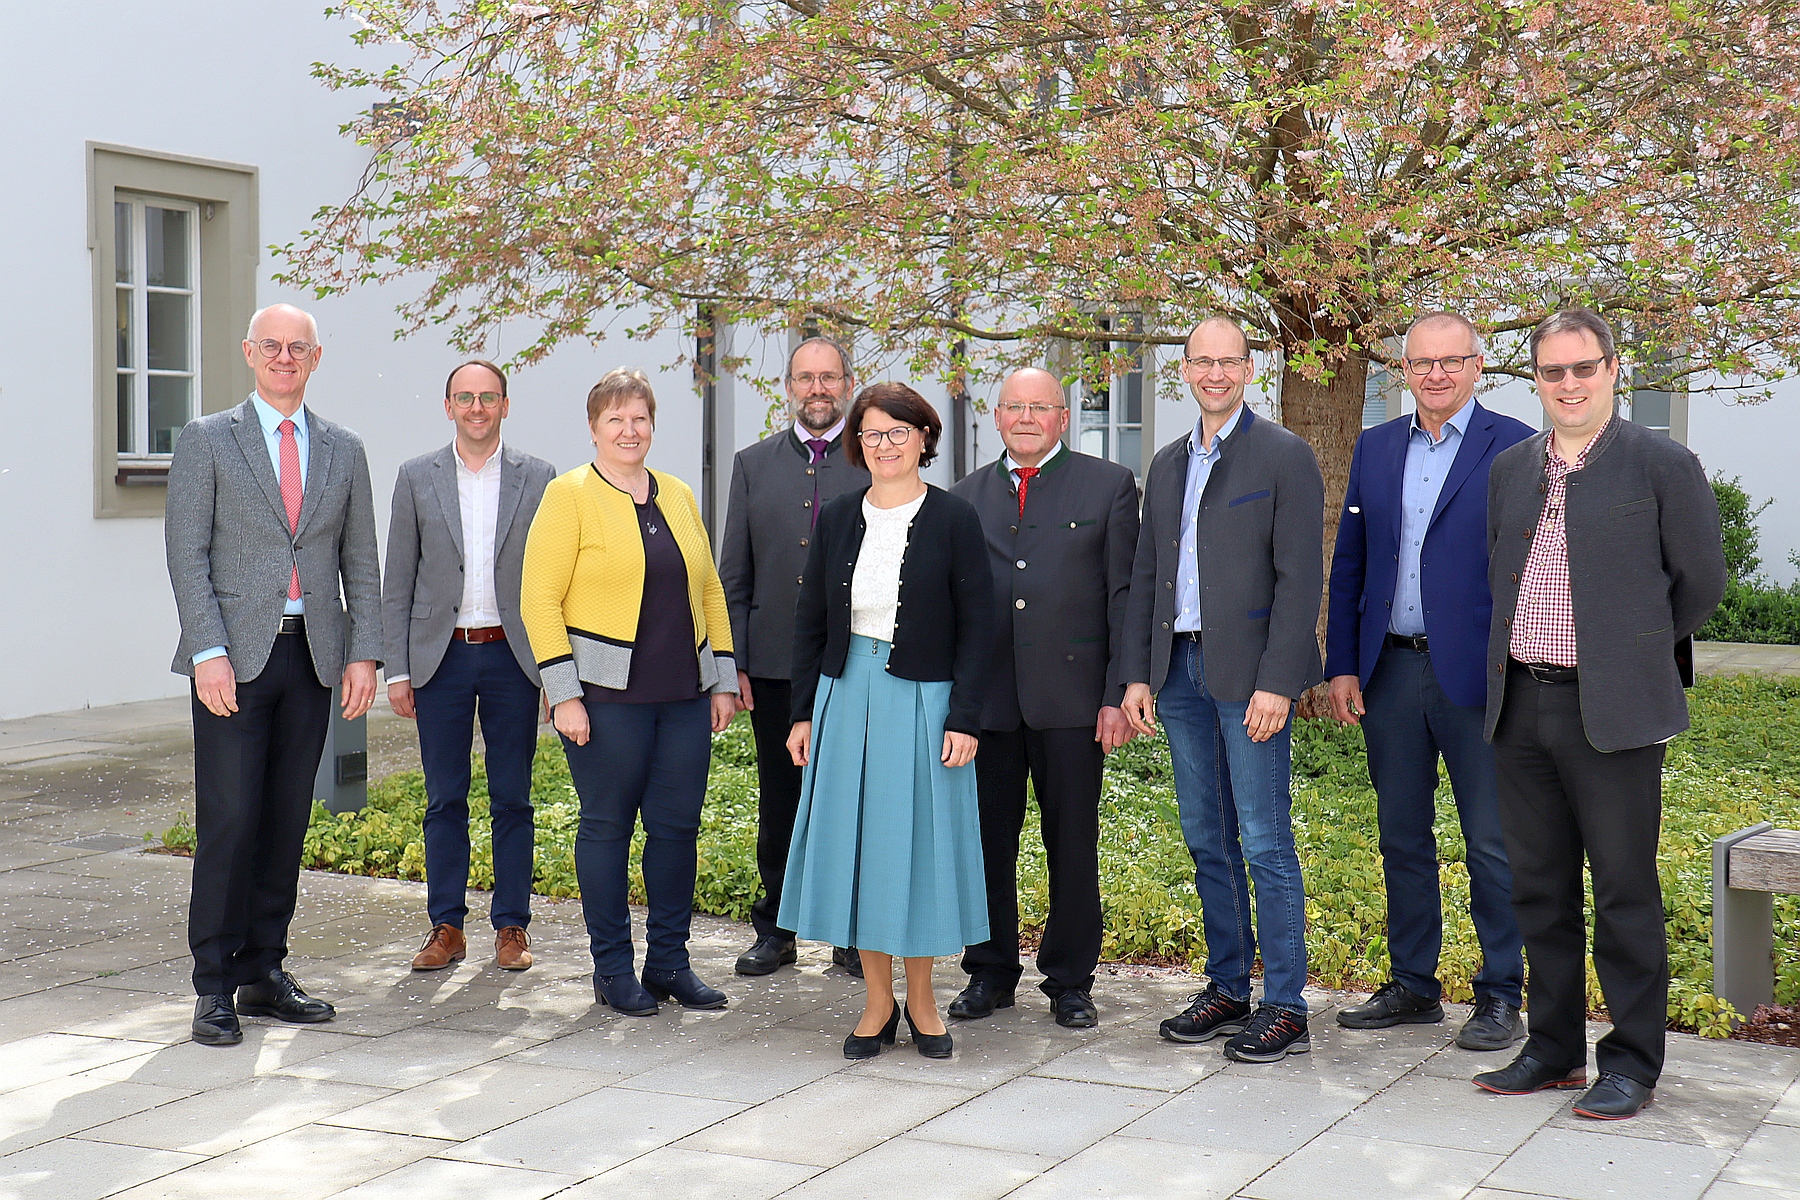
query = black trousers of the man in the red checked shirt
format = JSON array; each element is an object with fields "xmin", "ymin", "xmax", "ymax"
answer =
[{"xmin": 1494, "ymin": 666, "xmax": 1669, "ymax": 1087}]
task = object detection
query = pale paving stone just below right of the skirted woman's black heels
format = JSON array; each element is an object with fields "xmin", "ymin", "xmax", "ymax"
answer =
[{"xmin": 913, "ymin": 1076, "xmax": 1168, "ymax": 1159}]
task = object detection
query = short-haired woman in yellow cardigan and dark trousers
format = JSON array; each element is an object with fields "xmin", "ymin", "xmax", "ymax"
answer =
[{"xmin": 520, "ymin": 369, "xmax": 738, "ymax": 1016}]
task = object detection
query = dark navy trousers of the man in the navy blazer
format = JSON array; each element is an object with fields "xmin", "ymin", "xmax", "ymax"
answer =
[{"xmin": 1363, "ymin": 646, "xmax": 1525, "ymax": 1006}]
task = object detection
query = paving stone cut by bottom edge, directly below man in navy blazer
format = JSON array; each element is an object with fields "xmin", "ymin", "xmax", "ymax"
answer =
[{"xmin": 1244, "ymin": 1132, "xmax": 1501, "ymax": 1200}]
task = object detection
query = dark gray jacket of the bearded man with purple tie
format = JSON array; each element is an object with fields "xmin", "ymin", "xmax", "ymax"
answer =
[{"xmin": 718, "ymin": 426, "xmax": 869, "ymax": 680}]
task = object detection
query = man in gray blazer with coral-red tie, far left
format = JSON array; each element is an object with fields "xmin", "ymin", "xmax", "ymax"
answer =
[{"xmin": 164, "ymin": 304, "xmax": 382, "ymax": 1045}]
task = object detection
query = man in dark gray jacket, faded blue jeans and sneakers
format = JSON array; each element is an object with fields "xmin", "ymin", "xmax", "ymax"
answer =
[{"xmin": 1123, "ymin": 317, "xmax": 1325, "ymax": 1063}]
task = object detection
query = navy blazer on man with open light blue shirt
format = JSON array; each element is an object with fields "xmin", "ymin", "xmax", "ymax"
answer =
[{"xmin": 1325, "ymin": 399, "xmax": 1535, "ymax": 709}]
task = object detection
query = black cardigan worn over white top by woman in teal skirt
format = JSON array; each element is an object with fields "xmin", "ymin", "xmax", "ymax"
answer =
[{"xmin": 794, "ymin": 484, "xmax": 994, "ymax": 736}]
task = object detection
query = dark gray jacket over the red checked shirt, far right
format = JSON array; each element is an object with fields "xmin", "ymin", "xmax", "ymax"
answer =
[{"xmin": 1487, "ymin": 416, "xmax": 1726, "ymax": 754}]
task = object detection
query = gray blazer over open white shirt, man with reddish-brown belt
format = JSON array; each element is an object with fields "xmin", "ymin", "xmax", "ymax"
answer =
[{"xmin": 382, "ymin": 441, "xmax": 556, "ymax": 687}]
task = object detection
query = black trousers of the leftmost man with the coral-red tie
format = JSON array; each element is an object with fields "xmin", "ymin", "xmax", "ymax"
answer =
[{"xmin": 187, "ymin": 633, "xmax": 331, "ymax": 995}]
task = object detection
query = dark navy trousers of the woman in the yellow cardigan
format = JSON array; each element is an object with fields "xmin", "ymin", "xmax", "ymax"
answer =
[{"xmin": 563, "ymin": 696, "xmax": 713, "ymax": 975}]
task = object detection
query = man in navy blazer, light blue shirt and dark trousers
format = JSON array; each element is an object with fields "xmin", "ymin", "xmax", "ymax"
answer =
[{"xmin": 1325, "ymin": 313, "xmax": 1534, "ymax": 1051}]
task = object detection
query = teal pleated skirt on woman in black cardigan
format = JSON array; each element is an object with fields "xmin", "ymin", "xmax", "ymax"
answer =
[{"xmin": 776, "ymin": 635, "xmax": 988, "ymax": 957}]
